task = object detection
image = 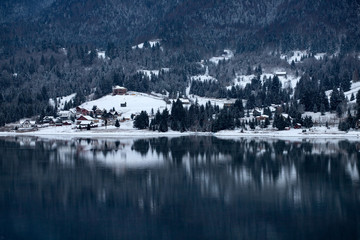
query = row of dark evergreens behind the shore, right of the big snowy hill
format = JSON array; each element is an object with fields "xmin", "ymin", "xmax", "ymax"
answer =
[{"xmin": 134, "ymin": 96, "xmax": 340, "ymax": 132}]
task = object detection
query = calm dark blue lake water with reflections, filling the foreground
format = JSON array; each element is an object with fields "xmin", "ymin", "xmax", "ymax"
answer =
[{"xmin": 0, "ymin": 137, "xmax": 360, "ymax": 239}]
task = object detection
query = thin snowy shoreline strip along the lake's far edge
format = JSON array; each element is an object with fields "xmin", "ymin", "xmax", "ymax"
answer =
[{"xmin": 0, "ymin": 124, "xmax": 360, "ymax": 141}]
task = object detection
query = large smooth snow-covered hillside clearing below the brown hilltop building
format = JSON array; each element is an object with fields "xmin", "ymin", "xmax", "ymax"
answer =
[{"xmin": 80, "ymin": 91, "xmax": 171, "ymax": 118}]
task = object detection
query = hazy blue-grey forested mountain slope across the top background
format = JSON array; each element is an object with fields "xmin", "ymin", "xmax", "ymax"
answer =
[{"xmin": 0, "ymin": 0, "xmax": 360, "ymax": 51}]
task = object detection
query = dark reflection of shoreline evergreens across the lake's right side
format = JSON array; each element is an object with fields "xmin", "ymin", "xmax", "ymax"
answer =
[{"xmin": 133, "ymin": 137, "xmax": 359, "ymax": 186}]
